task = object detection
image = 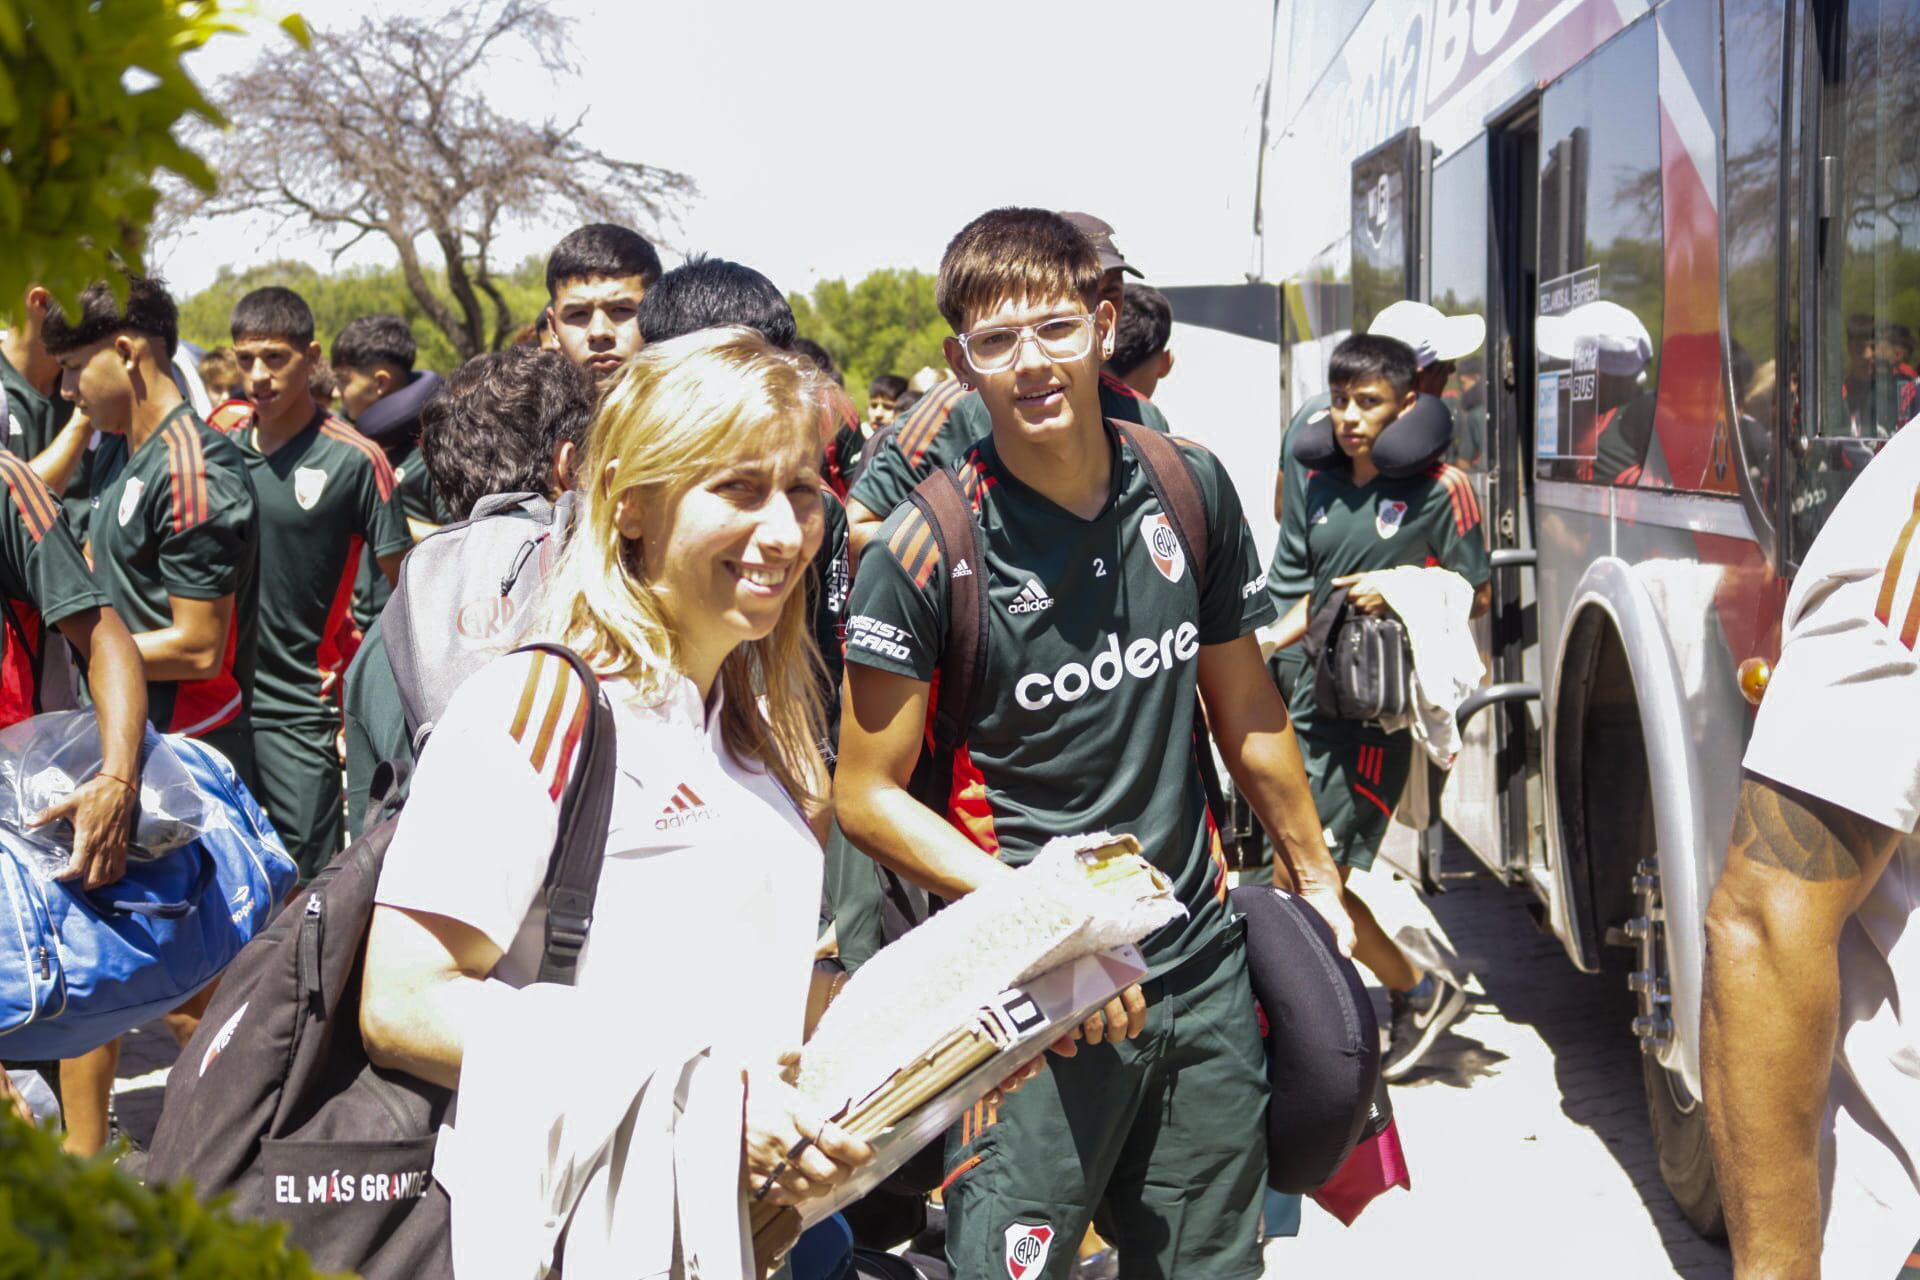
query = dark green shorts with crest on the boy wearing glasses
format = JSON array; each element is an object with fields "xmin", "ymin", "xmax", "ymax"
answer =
[{"xmin": 947, "ymin": 925, "xmax": 1267, "ymax": 1280}]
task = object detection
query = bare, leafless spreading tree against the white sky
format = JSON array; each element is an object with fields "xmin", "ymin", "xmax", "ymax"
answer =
[{"xmin": 178, "ymin": 0, "xmax": 693, "ymax": 361}]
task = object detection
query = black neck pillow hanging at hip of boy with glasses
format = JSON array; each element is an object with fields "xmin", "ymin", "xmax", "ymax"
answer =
[{"xmin": 1233, "ymin": 885, "xmax": 1380, "ymax": 1196}]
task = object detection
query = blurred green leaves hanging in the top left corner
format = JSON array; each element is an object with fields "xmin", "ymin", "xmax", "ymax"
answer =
[{"xmin": 0, "ymin": 0, "xmax": 305, "ymax": 318}]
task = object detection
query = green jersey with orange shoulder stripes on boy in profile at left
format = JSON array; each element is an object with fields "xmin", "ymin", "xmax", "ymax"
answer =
[{"xmin": 88, "ymin": 403, "xmax": 259, "ymax": 737}]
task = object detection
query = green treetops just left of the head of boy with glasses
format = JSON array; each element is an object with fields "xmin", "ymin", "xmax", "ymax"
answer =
[{"xmin": 787, "ymin": 269, "xmax": 952, "ymax": 403}]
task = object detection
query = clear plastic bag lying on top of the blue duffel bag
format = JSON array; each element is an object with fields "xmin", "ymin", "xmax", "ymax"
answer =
[{"xmin": 0, "ymin": 710, "xmax": 207, "ymax": 879}]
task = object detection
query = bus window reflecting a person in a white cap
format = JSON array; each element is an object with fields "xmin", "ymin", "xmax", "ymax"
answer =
[{"xmin": 1534, "ymin": 23, "xmax": 1666, "ymax": 484}]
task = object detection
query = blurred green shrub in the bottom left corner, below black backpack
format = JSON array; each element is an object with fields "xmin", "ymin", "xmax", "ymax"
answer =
[{"xmin": 0, "ymin": 1107, "xmax": 334, "ymax": 1280}]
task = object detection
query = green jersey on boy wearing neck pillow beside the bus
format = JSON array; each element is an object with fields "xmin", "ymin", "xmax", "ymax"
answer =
[{"xmin": 1275, "ymin": 462, "xmax": 1494, "ymax": 737}]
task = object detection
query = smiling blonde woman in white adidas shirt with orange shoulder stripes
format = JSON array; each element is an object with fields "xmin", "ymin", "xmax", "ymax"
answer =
[{"xmin": 361, "ymin": 328, "xmax": 872, "ymax": 1228}]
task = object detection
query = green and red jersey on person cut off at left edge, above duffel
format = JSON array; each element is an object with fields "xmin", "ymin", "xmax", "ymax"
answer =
[{"xmin": 0, "ymin": 453, "xmax": 108, "ymax": 725}]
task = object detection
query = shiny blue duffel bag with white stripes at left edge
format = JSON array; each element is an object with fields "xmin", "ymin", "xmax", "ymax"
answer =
[{"xmin": 0, "ymin": 737, "xmax": 300, "ymax": 1061}]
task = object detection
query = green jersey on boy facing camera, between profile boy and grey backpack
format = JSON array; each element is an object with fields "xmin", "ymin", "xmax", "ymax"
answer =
[{"xmin": 219, "ymin": 411, "xmax": 413, "ymax": 725}]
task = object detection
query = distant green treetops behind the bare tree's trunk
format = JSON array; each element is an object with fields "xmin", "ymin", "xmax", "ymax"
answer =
[{"xmin": 176, "ymin": 257, "xmax": 547, "ymax": 374}]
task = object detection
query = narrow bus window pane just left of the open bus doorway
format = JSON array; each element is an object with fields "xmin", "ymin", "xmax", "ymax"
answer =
[{"xmin": 1427, "ymin": 134, "xmax": 1488, "ymax": 477}]
